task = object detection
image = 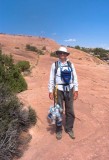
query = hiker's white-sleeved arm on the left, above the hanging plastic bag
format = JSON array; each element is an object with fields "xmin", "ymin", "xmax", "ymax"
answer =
[{"xmin": 48, "ymin": 63, "xmax": 55, "ymax": 100}]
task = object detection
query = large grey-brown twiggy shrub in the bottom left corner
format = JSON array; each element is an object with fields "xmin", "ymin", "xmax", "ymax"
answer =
[{"xmin": 0, "ymin": 83, "xmax": 37, "ymax": 160}]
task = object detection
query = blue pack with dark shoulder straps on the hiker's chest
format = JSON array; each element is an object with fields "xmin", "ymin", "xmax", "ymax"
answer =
[{"xmin": 54, "ymin": 61, "xmax": 73, "ymax": 85}]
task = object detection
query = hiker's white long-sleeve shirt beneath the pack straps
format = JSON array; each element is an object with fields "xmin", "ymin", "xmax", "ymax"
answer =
[{"xmin": 48, "ymin": 60, "xmax": 78, "ymax": 92}]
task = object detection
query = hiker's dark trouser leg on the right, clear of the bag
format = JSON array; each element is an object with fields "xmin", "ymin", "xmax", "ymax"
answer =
[{"xmin": 65, "ymin": 89, "xmax": 75, "ymax": 132}]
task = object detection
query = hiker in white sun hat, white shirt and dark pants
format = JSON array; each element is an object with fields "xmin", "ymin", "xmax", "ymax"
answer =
[{"xmin": 48, "ymin": 46, "xmax": 78, "ymax": 140}]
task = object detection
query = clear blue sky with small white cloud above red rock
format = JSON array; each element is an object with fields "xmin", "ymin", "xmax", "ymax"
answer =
[{"xmin": 0, "ymin": 0, "xmax": 109, "ymax": 49}]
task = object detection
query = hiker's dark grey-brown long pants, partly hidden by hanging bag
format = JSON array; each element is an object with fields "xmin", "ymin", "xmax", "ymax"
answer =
[{"xmin": 56, "ymin": 89, "xmax": 75, "ymax": 132}]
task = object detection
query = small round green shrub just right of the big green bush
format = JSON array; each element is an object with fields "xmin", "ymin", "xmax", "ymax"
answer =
[{"xmin": 16, "ymin": 61, "xmax": 30, "ymax": 72}]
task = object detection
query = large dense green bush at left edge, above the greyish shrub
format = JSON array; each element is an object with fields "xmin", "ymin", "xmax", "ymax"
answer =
[{"xmin": 0, "ymin": 52, "xmax": 27, "ymax": 93}]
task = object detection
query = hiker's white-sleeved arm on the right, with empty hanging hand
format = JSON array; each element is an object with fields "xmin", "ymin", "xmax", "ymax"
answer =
[{"xmin": 72, "ymin": 64, "xmax": 78, "ymax": 100}]
